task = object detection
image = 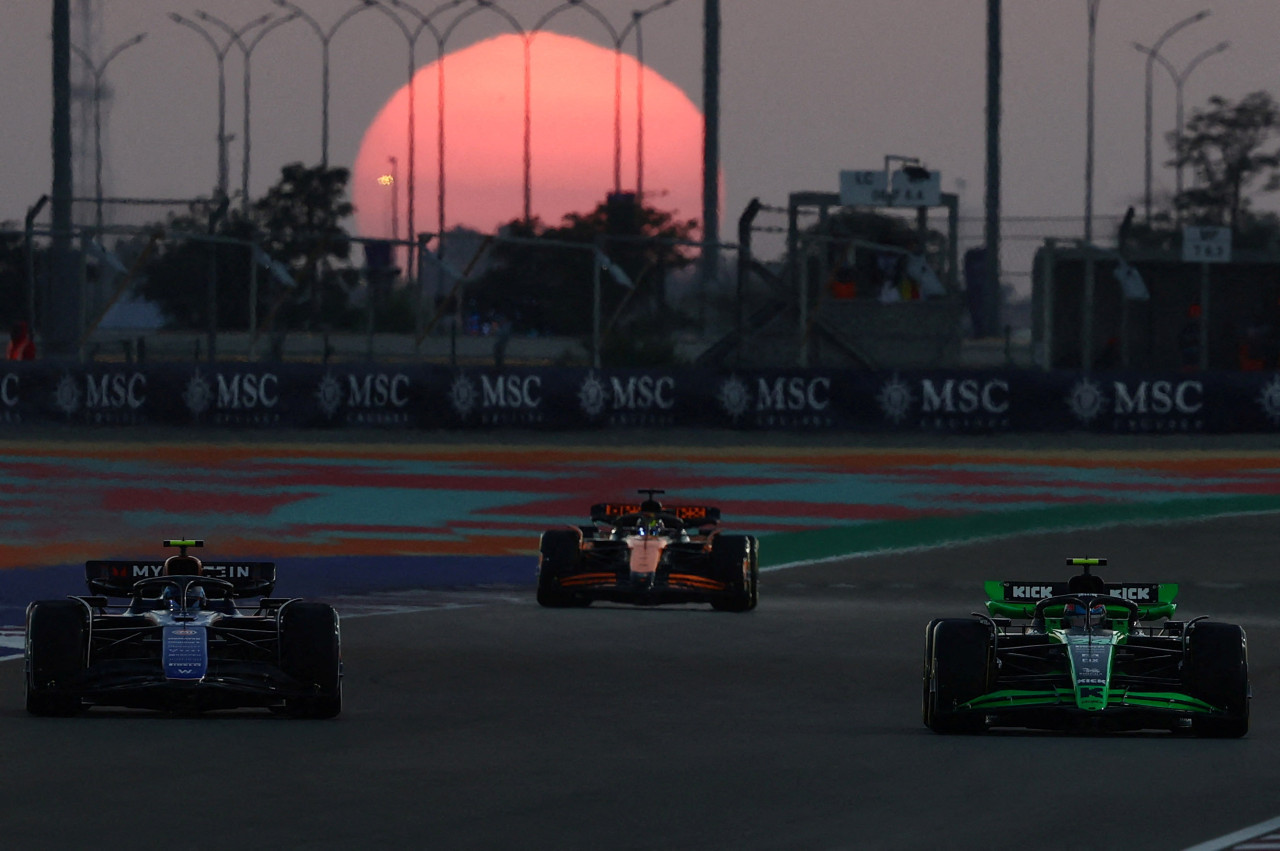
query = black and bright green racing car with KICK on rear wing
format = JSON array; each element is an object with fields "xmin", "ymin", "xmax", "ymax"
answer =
[{"xmin": 923, "ymin": 558, "xmax": 1251, "ymax": 737}]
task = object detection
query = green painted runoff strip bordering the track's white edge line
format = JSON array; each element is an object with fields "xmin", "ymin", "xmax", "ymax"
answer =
[{"xmin": 758, "ymin": 494, "xmax": 1280, "ymax": 567}]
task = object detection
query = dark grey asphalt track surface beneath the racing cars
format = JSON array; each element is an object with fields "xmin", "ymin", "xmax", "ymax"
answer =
[{"xmin": 0, "ymin": 514, "xmax": 1280, "ymax": 851}]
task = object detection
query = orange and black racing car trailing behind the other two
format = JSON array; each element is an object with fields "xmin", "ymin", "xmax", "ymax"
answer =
[{"xmin": 538, "ymin": 488, "xmax": 760, "ymax": 612}]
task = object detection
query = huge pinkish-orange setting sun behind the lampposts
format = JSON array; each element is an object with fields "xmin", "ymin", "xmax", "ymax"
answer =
[{"xmin": 351, "ymin": 32, "xmax": 703, "ymax": 238}]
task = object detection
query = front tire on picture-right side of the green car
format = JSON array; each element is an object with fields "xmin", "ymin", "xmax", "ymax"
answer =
[{"xmin": 1187, "ymin": 621, "xmax": 1249, "ymax": 738}]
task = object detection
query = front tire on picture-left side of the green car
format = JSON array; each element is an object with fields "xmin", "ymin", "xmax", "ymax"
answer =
[{"xmin": 924, "ymin": 618, "xmax": 991, "ymax": 733}]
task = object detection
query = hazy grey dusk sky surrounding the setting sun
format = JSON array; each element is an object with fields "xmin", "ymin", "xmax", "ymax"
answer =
[{"xmin": 0, "ymin": 0, "xmax": 1280, "ymax": 295}]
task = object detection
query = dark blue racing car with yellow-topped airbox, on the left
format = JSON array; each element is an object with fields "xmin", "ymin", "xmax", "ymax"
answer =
[{"xmin": 26, "ymin": 539, "xmax": 342, "ymax": 718}]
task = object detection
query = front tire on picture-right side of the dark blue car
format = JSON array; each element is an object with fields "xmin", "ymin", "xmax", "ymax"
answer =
[{"xmin": 280, "ymin": 601, "xmax": 342, "ymax": 718}]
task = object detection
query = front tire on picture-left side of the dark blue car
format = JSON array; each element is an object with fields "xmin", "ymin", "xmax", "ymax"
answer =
[{"xmin": 26, "ymin": 600, "xmax": 87, "ymax": 717}]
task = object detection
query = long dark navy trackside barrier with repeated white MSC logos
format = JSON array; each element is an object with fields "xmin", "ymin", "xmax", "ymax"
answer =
[{"xmin": 0, "ymin": 361, "xmax": 1280, "ymax": 435}]
